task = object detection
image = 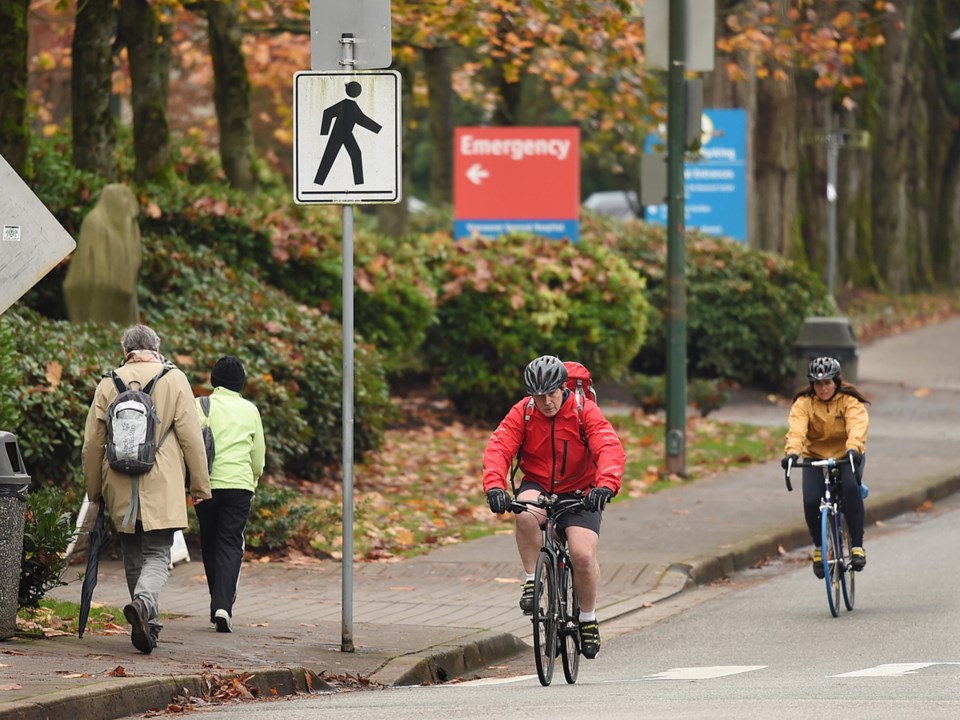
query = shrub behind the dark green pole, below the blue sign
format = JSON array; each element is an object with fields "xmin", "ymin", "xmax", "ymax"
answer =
[{"xmin": 584, "ymin": 216, "xmax": 834, "ymax": 388}]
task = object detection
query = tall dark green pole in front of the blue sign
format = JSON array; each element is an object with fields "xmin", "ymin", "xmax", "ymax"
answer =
[{"xmin": 666, "ymin": 0, "xmax": 687, "ymax": 475}]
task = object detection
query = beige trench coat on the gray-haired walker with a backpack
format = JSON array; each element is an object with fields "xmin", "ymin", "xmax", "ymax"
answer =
[{"xmin": 82, "ymin": 362, "xmax": 210, "ymax": 533}]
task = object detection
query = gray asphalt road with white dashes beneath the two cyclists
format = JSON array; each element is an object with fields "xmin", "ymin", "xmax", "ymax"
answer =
[{"xmin": 122, "ymin": 497, "xmax": 960, "ymax": 720}]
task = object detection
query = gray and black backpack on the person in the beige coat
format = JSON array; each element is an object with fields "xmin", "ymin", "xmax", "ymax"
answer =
[{"xmin": 104, "ymin": 365, "xmax": 173, "ymax": 476}]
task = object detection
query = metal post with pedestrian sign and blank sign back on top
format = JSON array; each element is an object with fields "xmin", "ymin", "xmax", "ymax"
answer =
[{"xmin": 304, "ymin": 0, "xmax": 401, "ymax": 652}]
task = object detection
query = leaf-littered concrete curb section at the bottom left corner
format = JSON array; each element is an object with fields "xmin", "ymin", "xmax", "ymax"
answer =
[{"xmin": 0, "ymin": 667, "xmax": 334, "ymax": 720}]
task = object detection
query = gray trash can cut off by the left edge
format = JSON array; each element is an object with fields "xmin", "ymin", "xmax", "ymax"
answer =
[{"xmin": 0, "ymin": 430, "xmax": 30, "ymax": 640}]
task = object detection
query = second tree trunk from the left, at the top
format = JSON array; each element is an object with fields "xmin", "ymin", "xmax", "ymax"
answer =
[{"xmin": 70, "ymin": 0, "xmax": 117, "ymax": 180}]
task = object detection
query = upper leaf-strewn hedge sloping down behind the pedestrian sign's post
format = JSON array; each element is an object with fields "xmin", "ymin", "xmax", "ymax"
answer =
[{"xmin": 142, "ymin": 186, "xmax": 435, "ymax": 374}]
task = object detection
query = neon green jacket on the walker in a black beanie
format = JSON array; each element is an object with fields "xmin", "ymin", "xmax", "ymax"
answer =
[{"xmin": 196, "ymin": 387, "xmax": 266, "ymax": 492}]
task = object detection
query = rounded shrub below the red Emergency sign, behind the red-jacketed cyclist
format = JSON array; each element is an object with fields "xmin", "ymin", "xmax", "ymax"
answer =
[{"xmin": 424, "ymin": 236, "xmax": 648, "ymax": 421}]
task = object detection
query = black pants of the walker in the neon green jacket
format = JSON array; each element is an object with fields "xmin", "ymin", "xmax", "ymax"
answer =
[{"xmin": 195, "ymin": 490, "xmax": 253, "ymax": 622}]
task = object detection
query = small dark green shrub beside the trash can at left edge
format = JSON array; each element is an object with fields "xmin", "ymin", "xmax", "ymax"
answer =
[{"xmin": 17, "ymin": 487, "xmax": 73, "ymax": 608}]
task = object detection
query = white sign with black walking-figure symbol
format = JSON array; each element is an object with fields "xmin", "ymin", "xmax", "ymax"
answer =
[{"xmin": 293, "ymin": 70, "xmax": 401, "ymax": 205}]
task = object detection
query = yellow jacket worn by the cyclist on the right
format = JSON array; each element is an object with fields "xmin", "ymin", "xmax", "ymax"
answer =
[{"xmin": 784, "ymin": 391, "xmax": 870, "ymax": 460}]
